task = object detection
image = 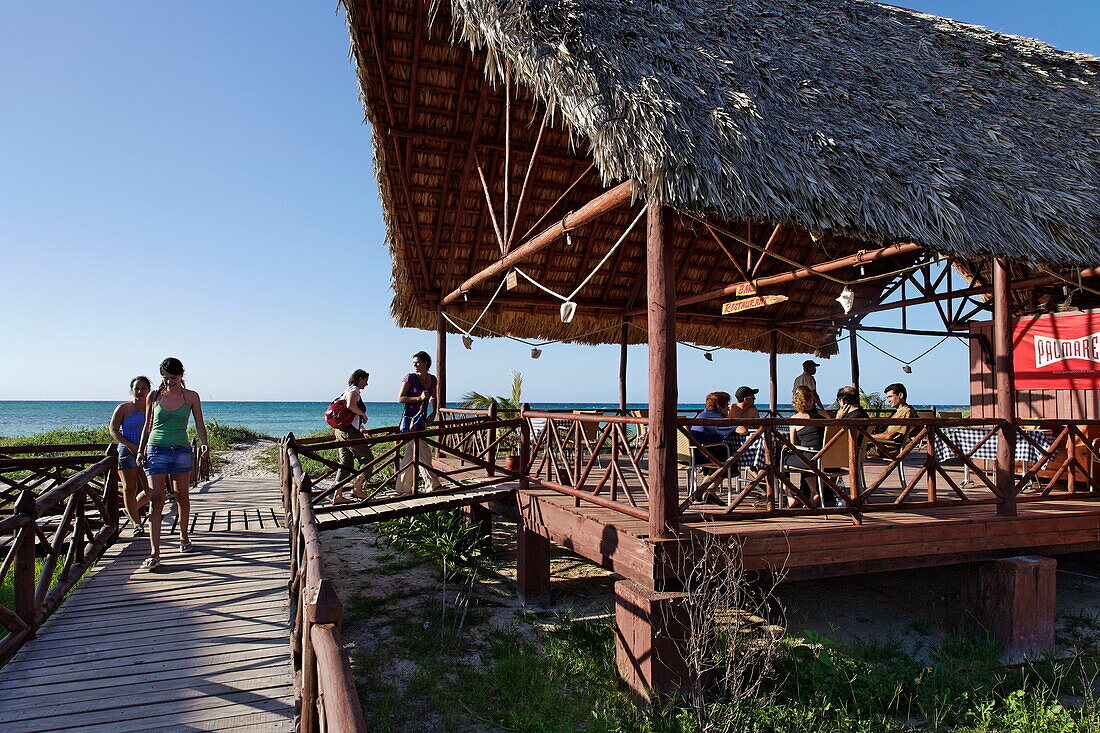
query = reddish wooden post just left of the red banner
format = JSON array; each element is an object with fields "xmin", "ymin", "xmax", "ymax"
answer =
[{"xmin": 993, "ymin": 258, "xmax": 1016, "ymax": 516}]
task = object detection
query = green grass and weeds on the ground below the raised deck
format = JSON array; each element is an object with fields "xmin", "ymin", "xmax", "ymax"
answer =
[{"xmin": 349, "ymin": 572, "xmax": 1100, "ymax": 733}]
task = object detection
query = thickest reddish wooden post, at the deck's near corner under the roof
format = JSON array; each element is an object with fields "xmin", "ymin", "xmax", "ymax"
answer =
[{"xmin": 646, "ymin": 199, "xmax": 680, "ymax": 538}]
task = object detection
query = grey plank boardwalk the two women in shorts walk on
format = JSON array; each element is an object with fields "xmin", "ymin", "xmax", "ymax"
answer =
[{"xmin": 0, "ymin": 477, "xmax": 295, "ymax": 733}]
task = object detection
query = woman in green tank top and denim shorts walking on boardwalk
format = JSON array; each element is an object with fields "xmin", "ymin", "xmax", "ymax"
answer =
[{"xmin": 138, "ymin": 357, "xmax": 208, "ymax": 570}]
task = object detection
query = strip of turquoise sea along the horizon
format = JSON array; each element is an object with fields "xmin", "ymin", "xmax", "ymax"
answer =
[{"xmin": 0, "ymin": 401, "xmax": 967, "ymax": 437}]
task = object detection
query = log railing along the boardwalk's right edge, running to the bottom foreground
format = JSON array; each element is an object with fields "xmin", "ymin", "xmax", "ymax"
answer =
[{"xmin": 279, "ymin": 435, "xmax": 366, "ymax": 733}]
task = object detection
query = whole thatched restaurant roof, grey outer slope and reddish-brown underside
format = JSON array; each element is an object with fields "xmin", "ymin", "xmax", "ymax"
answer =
[{"xmin": 345, "ymin": 0, "xmax": 1100, "ymax": 351}]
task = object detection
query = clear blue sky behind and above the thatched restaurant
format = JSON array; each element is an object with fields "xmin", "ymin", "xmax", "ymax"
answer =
[{"xmin": 0, "ymin": 0, "xmax": 1100, "ymax": 403}]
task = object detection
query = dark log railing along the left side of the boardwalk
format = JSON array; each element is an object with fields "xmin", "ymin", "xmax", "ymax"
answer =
[{"xmin": 0, "ymin": 445, "xmax": 119, "ymax": 657}]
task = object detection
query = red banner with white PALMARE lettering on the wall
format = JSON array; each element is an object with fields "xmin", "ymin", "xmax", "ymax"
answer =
[{"xmin": 1012, "ymin": 310, "xmax": 1100, "ymax": 390}]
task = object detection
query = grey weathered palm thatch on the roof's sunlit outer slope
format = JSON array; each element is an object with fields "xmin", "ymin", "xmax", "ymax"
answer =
[{"xmin": 453, "ymin": 0, "xmax": 1100, "ymax": 260}]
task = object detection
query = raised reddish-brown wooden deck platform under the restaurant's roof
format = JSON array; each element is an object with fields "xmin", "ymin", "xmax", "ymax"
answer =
[{"xmin": 437, "ymin": 458, "xmax": 1100, "ymax": 587}]
